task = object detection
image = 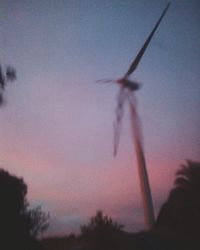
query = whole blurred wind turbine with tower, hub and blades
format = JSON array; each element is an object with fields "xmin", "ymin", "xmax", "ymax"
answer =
[{"xmin": 97, "ymin": 3, "xmax": 170, "ymax": 229}]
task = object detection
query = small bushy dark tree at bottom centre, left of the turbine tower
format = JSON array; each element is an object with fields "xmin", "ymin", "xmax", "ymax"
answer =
[{"xmin": 81, "ymin": 211, "xmax": 123, "ymax": 250}]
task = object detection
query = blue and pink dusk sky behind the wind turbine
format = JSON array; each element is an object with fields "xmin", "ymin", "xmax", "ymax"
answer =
[{"xmin": 0, "ymin": 0, "xmax": 200, "ymax": 234}]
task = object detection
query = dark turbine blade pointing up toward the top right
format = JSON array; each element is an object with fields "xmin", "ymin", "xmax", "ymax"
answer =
[{"xmin": 124, "ymin": 3, "xmax": 170, "ymax": 78}]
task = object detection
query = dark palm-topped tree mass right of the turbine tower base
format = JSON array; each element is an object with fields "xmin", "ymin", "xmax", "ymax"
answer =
[{"xmin": 155, "ymin": 161, "xmax": 200, "ymax": 249}]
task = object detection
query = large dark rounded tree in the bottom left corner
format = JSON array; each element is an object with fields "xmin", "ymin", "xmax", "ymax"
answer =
[{"xmin": 0, "ymin": 169, "xmax": 48, "ymax": 250}]
